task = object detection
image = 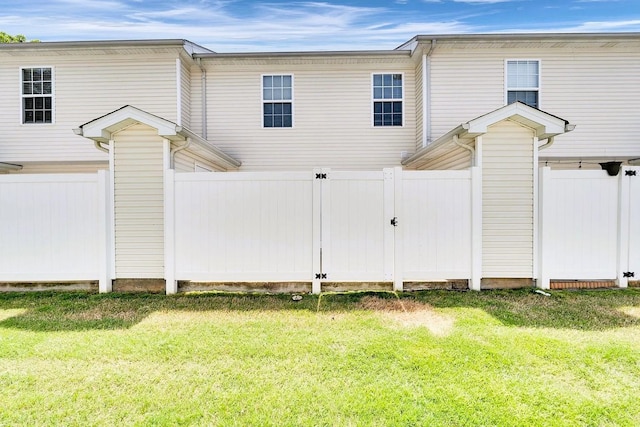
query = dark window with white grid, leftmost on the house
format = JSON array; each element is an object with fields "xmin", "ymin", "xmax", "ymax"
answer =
[{"xmin": 20, "ymin": 67, "xmax": 53, "ymax": 123}]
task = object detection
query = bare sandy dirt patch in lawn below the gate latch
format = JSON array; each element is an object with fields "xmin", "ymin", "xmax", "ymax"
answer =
[{"xmin": 359, "ymin": 296, "xmax": 455, "ymax": 336}]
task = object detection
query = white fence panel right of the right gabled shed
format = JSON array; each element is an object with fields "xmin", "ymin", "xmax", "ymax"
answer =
[{"xmin": 541, "ymin": 170, "xmax": 619, "ymax": 280}]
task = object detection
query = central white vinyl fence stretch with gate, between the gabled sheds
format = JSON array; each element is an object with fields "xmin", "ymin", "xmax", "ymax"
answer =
[{"xmin": 165, "ymin": 168, "xmax": 471, "ymax": 292}]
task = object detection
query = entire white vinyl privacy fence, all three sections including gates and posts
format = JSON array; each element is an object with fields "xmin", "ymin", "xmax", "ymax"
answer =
[{"xmin": 0, "ymin": 167, "xmax": 640, "ymax": 293}]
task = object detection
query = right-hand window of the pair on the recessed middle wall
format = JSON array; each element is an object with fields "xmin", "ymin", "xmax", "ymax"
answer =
[{"xmin": 373, "ymin": 74, "xmax": 403, "ymax": 126}]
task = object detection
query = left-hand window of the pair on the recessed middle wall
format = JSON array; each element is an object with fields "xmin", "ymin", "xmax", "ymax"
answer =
[{"xmin": 262, "ymin": 74, "xmax": 293, "ymax": 128}]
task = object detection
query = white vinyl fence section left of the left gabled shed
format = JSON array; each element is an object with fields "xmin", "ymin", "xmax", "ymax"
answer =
[{"xmin": 0, "ymin": 171, "xmax": 110, "ymax": 291}]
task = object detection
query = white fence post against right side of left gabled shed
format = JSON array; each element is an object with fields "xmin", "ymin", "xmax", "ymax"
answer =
[{"xmin": 164, "ymin": 169, "xmax": 178, "ymax": 295}]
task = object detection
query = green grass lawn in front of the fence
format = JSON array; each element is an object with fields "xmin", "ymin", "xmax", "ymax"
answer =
[{"xmin": 0, "ymin": 289, "xmax": 640, "ymax": 426}]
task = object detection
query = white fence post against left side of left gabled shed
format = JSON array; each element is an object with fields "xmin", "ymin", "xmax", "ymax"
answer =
[{"xmin": 97, "ymin": 170, "xmax": 113, "ymax": 293}]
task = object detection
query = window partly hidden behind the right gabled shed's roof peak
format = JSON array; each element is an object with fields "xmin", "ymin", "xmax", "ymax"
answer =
[{"xmin": 506, "ymin": 60, "xmax": 540, "ymax": 108}]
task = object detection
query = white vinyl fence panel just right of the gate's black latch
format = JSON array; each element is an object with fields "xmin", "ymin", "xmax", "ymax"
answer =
[{"xmin": 400, "ymin": 170, "xmax": 471, "ymax": 281}]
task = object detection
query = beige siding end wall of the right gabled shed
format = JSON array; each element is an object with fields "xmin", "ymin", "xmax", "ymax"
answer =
[{"xmin": 482, "ymin": 121, "xmax": 533, "ymax": 278}]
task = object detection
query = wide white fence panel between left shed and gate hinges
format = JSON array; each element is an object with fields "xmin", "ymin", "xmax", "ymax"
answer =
[{"xmin": 175, "ymin": 172, "xmax": 313, "ymax": 282}]
